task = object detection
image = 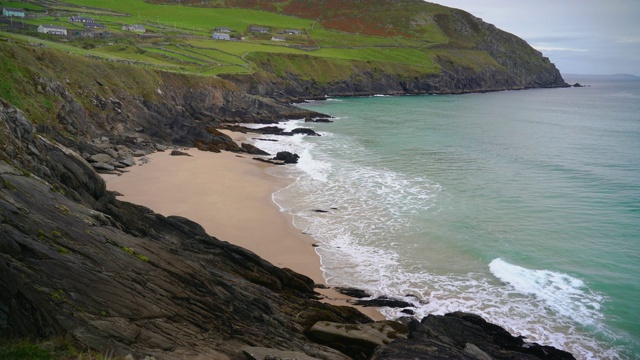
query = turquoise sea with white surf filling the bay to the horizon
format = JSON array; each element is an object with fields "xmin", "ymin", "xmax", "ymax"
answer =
[{"xmin": 246, "ymin": 78, "xmax": 640, "ymax": 359}]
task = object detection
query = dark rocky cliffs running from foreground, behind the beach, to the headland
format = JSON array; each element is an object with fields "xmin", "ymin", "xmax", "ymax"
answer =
[{"xmin": 0, "ymin": 32, "xmax": 572, "ymax": 359}]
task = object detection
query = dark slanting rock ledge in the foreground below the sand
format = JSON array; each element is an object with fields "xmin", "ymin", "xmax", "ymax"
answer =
[{"xmin": 0, "ymin": 101, "xmax": 573, "ymax": 359}]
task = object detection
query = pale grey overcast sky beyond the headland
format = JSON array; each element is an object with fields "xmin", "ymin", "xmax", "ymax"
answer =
[{"xmin": 430, "ymin": 0, "xmax": 640, "ymax": 76}]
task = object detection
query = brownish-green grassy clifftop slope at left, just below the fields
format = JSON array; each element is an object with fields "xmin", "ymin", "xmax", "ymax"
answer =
[{"xmin": 0, "ymin": 41, "xmax": 231, "ymax": 125}]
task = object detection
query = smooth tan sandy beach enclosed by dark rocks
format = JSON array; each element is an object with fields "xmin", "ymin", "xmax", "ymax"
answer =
[{"xmin": 103, "ymin": 132, "xmax": 384, "ymax": 320}]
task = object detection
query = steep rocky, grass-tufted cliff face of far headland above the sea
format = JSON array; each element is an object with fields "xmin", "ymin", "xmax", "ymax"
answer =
[{"xmin": 222, "ymin": 10, "xmax": 568, "ymax": 99}]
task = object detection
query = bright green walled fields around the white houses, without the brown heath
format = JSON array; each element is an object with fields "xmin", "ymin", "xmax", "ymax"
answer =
[{"xmin": 0, "ymin": 0, "xmax": 460, "ymax": 75}]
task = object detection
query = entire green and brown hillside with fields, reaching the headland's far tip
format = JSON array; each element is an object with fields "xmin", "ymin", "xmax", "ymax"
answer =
[{"xmin": 0, "ymin": 0, "xmax": 559, "ymax": 97}]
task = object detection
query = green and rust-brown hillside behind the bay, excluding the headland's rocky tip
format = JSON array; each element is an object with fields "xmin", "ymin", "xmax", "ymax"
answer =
[{"xmin": 0, "ymin": 0, "xmax": 536, "ymax": 91}]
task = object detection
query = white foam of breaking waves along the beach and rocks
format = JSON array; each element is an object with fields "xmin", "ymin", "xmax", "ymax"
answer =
[{"xmin": 251, "ymin": 122, "xmax": 617, "ymax": 359}]
